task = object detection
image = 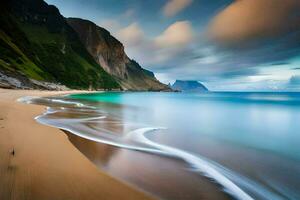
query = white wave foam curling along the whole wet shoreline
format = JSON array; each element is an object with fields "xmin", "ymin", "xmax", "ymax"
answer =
[{"xmin": 18, "ymin": 97, "xmax": 284, "ymax": 200}]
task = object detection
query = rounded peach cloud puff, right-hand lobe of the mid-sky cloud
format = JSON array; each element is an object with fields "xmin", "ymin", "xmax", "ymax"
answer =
[{"xmin": 155, "ymin": 21, "xmax": 193, "ymax": 48}]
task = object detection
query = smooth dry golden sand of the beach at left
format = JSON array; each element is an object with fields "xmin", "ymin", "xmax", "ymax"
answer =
[{"xmin": 0, "ymin": 89, "xmax": 151, "ymax": 200}]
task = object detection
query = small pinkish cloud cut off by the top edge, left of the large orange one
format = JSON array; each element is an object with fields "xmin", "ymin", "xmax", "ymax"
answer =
[{"xmin": 163, "ymin": 0, "xmax": 193, "ymax": 17}]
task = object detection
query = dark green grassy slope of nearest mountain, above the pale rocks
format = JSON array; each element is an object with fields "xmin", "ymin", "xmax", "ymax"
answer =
[{"xmin": 0, "ymin": 1, "xmax": 119, "ymax": 89}]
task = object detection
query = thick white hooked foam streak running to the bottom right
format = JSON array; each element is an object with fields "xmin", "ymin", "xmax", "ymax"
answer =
[{"xmin": 130, "ymin": 128, "xmax": 282, "ymax": 200}]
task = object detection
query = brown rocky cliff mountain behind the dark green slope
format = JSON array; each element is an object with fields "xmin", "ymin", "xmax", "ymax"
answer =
[{"xmin": 67, "ymin": 18, "xmax": 170, "ymax": 90}]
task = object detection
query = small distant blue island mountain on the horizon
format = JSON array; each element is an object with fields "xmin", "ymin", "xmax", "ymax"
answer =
[{"xmin": 172, "ymin": 80, "xmax": 208, "ymax": 92}]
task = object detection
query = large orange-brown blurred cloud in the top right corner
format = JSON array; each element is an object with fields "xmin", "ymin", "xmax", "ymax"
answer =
[{"xmin": 208, "ymin": 0, "xmax": 300, "ymax": 45}]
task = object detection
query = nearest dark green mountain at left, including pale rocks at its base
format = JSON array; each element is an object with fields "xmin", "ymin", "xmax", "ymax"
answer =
[{"xmin": 0, "ymin": 0, "xmax": 120, "ymax": 89}]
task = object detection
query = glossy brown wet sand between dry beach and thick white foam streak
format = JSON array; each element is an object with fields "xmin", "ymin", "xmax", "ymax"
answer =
[{"xmin": 67, "ymin": 130, "xmax": 231, "ymax": 200}]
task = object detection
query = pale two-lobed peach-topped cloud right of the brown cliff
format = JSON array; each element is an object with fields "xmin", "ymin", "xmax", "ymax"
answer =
[{"xmin": 115, "ymin": 21, "xmax": 194, "ymax": 66}]
